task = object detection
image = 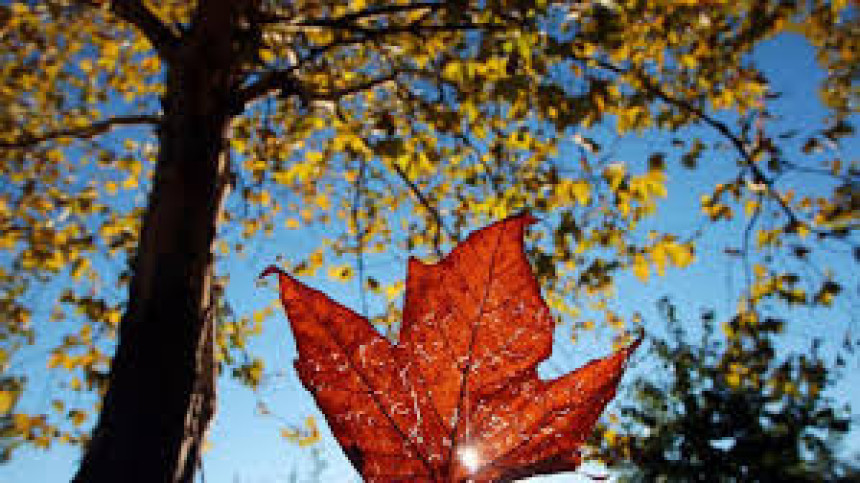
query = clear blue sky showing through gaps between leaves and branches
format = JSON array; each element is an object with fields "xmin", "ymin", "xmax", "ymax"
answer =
[{"xmin": 0, "ymin": 24, "xmax": 860, "ymax": 483}]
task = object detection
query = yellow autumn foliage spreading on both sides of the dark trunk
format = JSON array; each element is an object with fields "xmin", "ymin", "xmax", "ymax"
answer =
[{"xmin": 0, "ymin": 0, "xmax": 858, "ymax": 462}]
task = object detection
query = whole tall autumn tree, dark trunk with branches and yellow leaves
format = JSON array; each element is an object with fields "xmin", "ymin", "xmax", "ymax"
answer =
[{"xmin": 0, "ymin": 0, "xmax": 860, "ymax": 481}]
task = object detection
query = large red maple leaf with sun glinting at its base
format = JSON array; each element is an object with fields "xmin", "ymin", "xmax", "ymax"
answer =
[{"xmin": 262, "ymin": 215, "xmax": 639, "ymax": 481}]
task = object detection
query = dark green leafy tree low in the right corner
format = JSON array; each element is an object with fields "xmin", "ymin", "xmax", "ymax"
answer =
[{"xmin": 595, "ymin": 299, "xmax": 857, "ymax": 481}]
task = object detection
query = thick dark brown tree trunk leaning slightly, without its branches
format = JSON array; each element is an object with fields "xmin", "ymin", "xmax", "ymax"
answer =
[{"xmin": 74, "ymin": 0, "xmax": 255, "ymax": 483}]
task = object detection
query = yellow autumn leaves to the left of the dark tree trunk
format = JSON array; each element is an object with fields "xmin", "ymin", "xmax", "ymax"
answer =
[{"xmin": 0, "ymin": 2, "xmax": 170, "ymax": 458}]
